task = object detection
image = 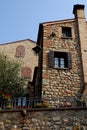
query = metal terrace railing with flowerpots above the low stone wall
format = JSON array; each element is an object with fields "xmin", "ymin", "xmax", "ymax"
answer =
[{"xmin": 0, "ymin": 96, "xmax": 87, "ymax": 110}]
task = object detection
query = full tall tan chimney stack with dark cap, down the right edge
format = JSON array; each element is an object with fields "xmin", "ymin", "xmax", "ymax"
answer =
[{"xmin": 73, "ymin": 4, "xmax": 87, "ymax": 86}]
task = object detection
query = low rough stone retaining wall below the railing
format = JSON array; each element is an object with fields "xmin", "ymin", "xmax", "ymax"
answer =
[{"xmin": 0, "ymin": 109, "xmax": 87, "ymax": 130}]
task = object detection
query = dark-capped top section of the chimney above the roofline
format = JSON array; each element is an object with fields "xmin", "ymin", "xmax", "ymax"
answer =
[{"xmin": 73, "ymin": 4, "xmax": 85, "ymax": 18}]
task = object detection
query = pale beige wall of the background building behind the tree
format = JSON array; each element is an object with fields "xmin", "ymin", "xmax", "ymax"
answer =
[{"xmin": 0, "ymin": 40, "xmax": 38, "ymax": 81}]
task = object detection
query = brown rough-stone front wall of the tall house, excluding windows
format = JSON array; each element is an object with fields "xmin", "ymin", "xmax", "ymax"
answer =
[{"xmin": 42, "ymin": 19, "xmax": 83, "ymax": 97}]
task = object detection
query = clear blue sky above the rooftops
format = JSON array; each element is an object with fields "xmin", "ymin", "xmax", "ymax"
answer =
[{"xmin": 0, "ymin": 0, "xmax": 87, "ymax": 44}]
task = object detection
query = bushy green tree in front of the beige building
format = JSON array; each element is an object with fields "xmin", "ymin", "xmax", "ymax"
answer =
[{"xmin": 0, "ymin": 54, "xmax": 25, "ymax": 98}]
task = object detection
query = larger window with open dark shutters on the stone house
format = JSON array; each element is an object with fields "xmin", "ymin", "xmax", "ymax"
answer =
[{"xmin": 48, "ymin": 51, "xmax": 72, "ymax": 68}]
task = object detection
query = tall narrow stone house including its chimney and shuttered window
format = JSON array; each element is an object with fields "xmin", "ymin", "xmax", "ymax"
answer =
[{"xmin": 36, "ymin": 4, "xmax": 87, "ymax": 101}]
